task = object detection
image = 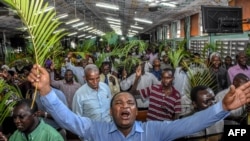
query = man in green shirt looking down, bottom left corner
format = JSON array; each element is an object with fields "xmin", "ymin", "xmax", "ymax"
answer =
[{"xmin": 3, "ymin": 99, "xmax": 64, "ymax": 141}]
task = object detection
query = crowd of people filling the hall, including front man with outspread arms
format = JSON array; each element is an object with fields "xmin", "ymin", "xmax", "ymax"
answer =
[{"xmin": 0, "ymin": 45, "xmax": 250, "ymax": 141}]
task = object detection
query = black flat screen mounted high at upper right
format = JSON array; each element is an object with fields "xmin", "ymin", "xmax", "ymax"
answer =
[{"xmin": 201, "ymin": 5, "xmax": 243, "ymax": 33}]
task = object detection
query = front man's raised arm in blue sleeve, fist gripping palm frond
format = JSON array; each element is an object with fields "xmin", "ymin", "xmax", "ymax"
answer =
[{"xmin": 28, "ymin": 65, "xmax": 92, "ymax": 137}]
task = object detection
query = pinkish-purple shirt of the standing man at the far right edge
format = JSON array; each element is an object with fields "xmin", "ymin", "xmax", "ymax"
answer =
[{"xmin": 228, "ymin": 64, "xmax": 250, "ymax": 83}]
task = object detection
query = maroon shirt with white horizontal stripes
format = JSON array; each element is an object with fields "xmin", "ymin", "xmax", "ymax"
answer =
[{"xmin": 140, "ymin": 85, "xmax": 181, "ymax": 121}]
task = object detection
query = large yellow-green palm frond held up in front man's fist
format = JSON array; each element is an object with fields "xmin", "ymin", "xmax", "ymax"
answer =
[{"xmin": 2, "ymin": 0, "xmax": 65, "ymax": 107}]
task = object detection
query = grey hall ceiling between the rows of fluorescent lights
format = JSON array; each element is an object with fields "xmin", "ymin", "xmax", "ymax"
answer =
[{"xmin": 0, "ymin": 0, "xmax": 228, "ymax": 37}]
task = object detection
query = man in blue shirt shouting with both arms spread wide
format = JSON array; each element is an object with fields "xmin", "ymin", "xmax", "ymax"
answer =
[{"xmin": 25, "ymin": 65, "xmax": 250, "ymax": 141}]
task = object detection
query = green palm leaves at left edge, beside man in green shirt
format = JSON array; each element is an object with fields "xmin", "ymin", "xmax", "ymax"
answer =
[{"xmin": 0, "ymin": 79, "xmax": 23, "ymax": 125}]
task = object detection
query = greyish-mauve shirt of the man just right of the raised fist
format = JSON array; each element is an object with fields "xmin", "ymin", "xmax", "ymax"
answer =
[{"xmin": 50, "ymin": 72, "xmax": 81, "ymax": 109}]
